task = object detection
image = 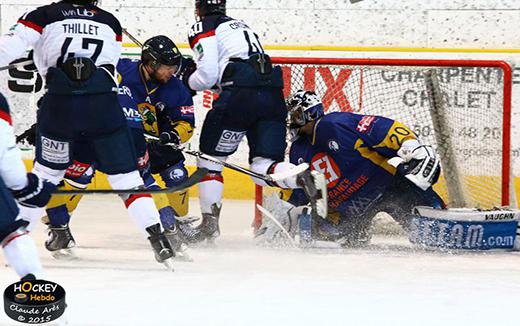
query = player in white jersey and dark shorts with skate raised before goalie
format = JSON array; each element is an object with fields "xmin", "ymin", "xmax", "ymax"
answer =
[{"xmin": 176, "ymin": 0, "xmax": 326, "ymax": 241}]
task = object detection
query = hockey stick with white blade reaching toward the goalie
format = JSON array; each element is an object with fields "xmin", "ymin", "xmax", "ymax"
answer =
[{"xmin": 145, "ymin": 134, "xmax": 309, "ymax": 184}]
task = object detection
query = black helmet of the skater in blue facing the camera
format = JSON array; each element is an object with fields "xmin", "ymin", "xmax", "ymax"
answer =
[{"xmin": 141, "ymin": 35, "xmax": 182, "ymax": 69}]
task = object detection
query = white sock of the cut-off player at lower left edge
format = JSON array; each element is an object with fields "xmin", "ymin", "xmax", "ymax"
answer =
[{"xmin": 4, "ymin": 233, "xmax": 43, "ymax": 279}]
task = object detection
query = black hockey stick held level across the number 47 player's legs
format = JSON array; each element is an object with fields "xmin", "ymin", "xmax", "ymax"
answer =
[{"xmin": 53, "ymin": 168, "xmax": 208, "ymax": 195}]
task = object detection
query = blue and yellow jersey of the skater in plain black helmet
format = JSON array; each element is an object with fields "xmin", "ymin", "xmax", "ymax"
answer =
[{"xmin": 117, "ymin": 59, "xmax": 195, "ymax": 142}]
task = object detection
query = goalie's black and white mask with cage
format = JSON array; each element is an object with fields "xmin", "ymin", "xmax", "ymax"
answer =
[{"xmin": 286, "ymin": 90, "xmax": 325, "ymax": 129}]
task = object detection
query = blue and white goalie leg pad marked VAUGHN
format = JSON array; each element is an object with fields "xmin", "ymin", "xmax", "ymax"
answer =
[{"xmin": 409, "ymin": 206, "xmax": 520, "ymax": 250}]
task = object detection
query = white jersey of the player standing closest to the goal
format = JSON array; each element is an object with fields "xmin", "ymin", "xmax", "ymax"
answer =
[{"xmin": 189, "ymin": 15, "xmax": 264, "ymax": 91}]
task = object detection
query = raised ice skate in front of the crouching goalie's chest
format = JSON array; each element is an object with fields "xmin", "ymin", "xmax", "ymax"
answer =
[{"xmin": 296, "ymin": 170, "xmax": 327, "ymax": 219}]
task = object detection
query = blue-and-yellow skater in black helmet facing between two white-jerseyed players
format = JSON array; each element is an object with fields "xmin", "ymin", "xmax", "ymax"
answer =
[{"xmin": 42, "ymin": 36, "xmax": 195, "ymax": 259}]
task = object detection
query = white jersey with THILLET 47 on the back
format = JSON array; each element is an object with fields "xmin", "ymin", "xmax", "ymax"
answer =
[{"xmin": 0, "ymin": 2, "xmax": 122, "ymax": 76}]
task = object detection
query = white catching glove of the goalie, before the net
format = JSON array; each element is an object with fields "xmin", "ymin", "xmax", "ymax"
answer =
[{"xmin": 388, "ymin": 139, "xmax": 441, "ymax": 190}]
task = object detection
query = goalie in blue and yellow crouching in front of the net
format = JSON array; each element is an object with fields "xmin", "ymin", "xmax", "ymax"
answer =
[{"xmin": 257, "ymin": 90, "xmax": 445, "ymax": 246}]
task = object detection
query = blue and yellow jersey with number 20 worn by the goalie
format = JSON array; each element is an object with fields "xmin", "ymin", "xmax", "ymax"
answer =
[{"xmin": 290, "ymin": 112, "xmax": 416, "ymax": 216}]
